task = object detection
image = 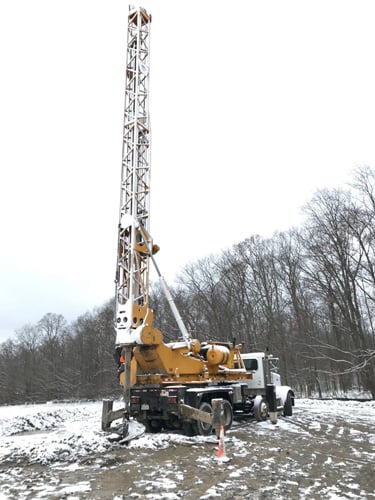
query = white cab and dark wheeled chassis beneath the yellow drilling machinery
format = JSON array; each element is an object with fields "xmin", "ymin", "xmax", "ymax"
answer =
[{"xmin": 130, "ymin": 344, "xmax": 295, "ymax": 435}]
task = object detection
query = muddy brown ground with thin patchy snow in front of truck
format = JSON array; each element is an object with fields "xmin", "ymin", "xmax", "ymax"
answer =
[{"xmin": 0, "ymin": 400, "xmax": 375, "ymax": 500}]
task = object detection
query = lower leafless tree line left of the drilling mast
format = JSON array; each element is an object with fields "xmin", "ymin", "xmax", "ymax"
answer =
[{"xmin": 0, "ymin": 301, "xmax": 118, "ymax": 404}]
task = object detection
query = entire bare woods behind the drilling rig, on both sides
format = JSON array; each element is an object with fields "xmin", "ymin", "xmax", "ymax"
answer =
[{"xmin": 0, "ymin": 167, "xmax": 375, "ymax": 404}]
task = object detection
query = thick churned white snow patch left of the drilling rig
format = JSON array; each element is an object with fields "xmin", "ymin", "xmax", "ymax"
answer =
[{"xmin": 0, "ymin": 402, "xmax": 110, "ymax": 464}]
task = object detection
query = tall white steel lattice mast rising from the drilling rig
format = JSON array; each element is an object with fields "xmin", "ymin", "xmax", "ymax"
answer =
[{"xmin": 116, "ymin": 8, "xmax": 152, "ymax": 342}]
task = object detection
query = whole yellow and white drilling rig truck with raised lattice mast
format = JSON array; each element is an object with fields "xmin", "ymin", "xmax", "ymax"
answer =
[{"xmin": 102, "ymin": 7, "xmax": 294, "ymax": 436}]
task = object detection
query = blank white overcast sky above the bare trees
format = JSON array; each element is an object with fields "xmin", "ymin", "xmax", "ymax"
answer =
[{"xmin": 0, "ymin": 0, "xmax": 375, "ymax": 340}]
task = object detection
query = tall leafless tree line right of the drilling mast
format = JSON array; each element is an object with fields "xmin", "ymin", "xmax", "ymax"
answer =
[{"xmin": 153, "ymin": 167, "xmax": 375, "ymax": 397}]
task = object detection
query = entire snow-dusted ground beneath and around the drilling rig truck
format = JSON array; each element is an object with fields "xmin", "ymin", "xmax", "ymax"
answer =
[{"xmin": 0, "ymin": 399, "xmax": 375, "ymax": 500}]
